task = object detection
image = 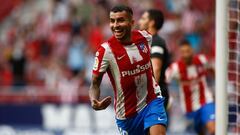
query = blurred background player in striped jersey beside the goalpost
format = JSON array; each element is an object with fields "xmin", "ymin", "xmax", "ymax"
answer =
[{"xmin": 166, "ymin": 40, "xmax": 215, "ymax": 135}]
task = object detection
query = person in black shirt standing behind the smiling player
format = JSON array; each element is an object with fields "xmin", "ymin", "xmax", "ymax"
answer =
[{"xmin": 138, "ymin": 9, "xmax": 169, "ymax": 108}]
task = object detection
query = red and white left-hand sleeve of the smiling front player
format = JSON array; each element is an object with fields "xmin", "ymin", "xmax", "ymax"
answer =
[{"xmin": 93, "ymin": 46, "xmax": 109, "ymax": 75}]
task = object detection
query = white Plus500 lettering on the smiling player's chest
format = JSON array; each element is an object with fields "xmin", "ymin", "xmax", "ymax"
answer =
[{"xmin": 121, "ymin": 62, "xmax": 151, "ymax": 77}]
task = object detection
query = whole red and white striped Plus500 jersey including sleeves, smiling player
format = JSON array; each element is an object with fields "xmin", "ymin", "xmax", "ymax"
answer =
[{"xmin": 93, "ymin": 31, "xmax": 160, "ymax": 119}]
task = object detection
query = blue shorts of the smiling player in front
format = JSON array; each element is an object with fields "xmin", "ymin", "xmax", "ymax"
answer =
[{"xmin": 116, "ymin": 98, "xmax": 167, "ymax": 135}]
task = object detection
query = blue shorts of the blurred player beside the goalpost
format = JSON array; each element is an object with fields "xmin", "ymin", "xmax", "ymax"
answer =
[{"xmin": 187, "ymin": 103, "xmax": 215, "ymax": 132}]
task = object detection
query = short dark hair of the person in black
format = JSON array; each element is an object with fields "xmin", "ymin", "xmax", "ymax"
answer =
[{"xmin": 147, "ymin": 9, "xmax": 164, "ymax": 30}]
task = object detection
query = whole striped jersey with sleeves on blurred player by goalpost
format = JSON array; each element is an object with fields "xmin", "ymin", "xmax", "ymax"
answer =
[{"xmin": 165, "ymin": 55, "xmax": 213, "ymax": 113}]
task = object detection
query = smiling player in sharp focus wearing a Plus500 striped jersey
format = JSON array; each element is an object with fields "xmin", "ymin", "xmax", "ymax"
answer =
[{"xmin": 89, "ymin": 5, "xmax": 167, "ymax": 135}]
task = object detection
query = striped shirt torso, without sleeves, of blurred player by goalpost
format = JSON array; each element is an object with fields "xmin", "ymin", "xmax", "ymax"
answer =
[{"xmin": 178, "ymin": 57, "xmax": 213, "ymax": 112}]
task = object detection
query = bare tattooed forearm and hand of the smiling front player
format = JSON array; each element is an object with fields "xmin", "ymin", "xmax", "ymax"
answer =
[{"xmin": 89, "ymin": 73, "xmax": 111, "ymax": 110}]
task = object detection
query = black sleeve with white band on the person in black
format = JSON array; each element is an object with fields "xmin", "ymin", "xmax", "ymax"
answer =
[{"xmin": 151, "ymin": 40, "xmax": 166, "ymax": 59}]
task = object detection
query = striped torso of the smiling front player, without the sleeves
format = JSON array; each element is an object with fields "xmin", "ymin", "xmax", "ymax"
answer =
[{"xmin": 108, "ymin": 30, "xmax": 155, "ymax": 118}]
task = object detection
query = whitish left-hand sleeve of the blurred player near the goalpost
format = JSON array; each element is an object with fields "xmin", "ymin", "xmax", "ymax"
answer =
[{"xmin": 165, "ymin": 63, "xmax": 180, "ymax": 83}]
